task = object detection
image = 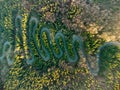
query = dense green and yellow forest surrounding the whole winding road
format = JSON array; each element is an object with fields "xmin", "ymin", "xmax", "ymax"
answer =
[{"xmin": 0, "ymin": 0, "xmax": 120, "ymax": 90}]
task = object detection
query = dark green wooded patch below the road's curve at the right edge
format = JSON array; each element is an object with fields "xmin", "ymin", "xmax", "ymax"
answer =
[{"xmin": 99, "ymin": 45, "xmax": 120, "ymax": 75}]
